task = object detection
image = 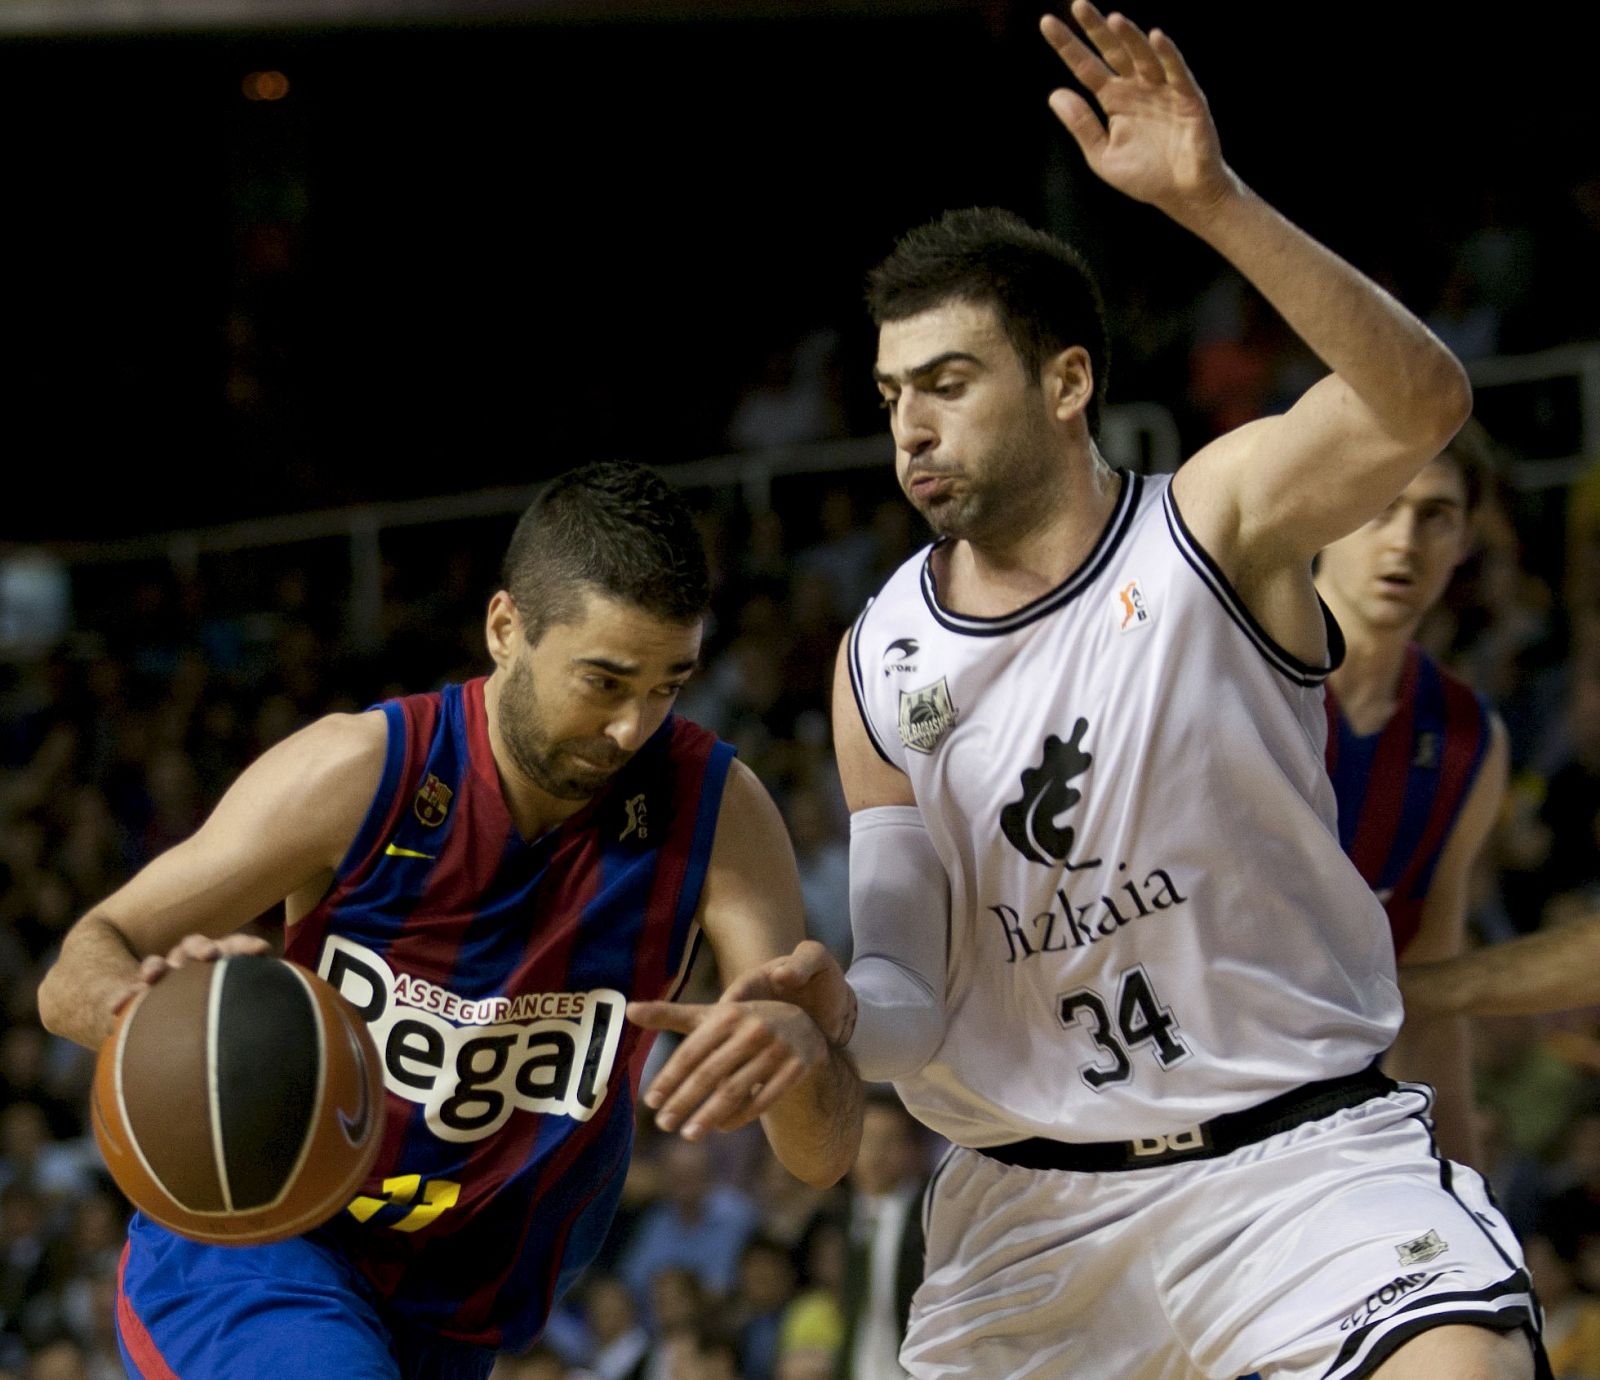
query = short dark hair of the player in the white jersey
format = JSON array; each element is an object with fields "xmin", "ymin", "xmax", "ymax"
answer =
[{"xmin": 867, "ymin": 207, "xmax": 1110, "ymax": 435}]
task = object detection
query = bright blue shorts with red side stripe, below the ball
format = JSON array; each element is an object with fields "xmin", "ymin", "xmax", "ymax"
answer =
[{"xmin": 117, "ymin": 1212, "xmax": 494, "ymax": 1380}]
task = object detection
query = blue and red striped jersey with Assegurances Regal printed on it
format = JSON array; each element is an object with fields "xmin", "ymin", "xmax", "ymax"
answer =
[{"xmin": 286, "ymin": 680, "xmax": 733, "ymax": 1350}]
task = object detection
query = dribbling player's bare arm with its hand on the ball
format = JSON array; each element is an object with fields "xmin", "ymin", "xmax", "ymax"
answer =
[{"xmin": 38, "ymin": 714, "xmax": 387, "ymax": 1049}]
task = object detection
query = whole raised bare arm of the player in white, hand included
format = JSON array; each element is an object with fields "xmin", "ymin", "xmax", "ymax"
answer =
[{"xmin": 1042, "ymin": 0, "xmax": 1470, "ymax": 566}]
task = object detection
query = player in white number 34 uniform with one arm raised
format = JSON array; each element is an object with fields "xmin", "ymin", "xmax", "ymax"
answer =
[{"xmin": 646, "ymin": 0, "xmax": 1539, "ymax": 1380}]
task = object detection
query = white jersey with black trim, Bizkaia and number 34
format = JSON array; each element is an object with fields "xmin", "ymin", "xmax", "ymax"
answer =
[{"xmin": 850, "ymin": 475, "xmax": 1400, "ymax": 1146}]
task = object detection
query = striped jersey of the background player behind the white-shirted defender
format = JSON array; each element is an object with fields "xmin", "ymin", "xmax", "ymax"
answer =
[{"xmin": 1328, "ymin": 642, "xmax": 1490, "ymax": 954}]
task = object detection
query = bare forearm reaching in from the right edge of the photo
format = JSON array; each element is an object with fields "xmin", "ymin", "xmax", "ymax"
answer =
[{"xmin": 1400, "ymin": 916, "xmax": 1600, "ymax": 1017}]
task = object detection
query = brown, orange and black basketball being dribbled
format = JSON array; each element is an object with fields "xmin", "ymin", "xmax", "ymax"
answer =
[{"xmin": 90, "ymin": 957, "xmax": 384, "ymax": 1246}]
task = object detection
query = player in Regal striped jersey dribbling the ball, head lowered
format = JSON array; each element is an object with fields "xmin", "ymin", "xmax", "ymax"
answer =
[{"xmin": 40, "ymin": 464, "xmax": 861, "ymax": 1380}]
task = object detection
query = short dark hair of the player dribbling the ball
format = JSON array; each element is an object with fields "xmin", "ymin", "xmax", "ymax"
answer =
[{"xmin": 501, "ymin": 461, "xmax": 710, "ymax": 642}]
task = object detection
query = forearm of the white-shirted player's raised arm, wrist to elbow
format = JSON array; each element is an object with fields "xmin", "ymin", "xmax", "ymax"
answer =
[{"xmin": 1166, "ymin": 175, "xmax": 1472, "ymax": 456}]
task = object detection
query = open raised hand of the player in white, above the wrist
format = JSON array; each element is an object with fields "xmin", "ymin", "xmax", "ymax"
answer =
[{"xmin": 1038, "ymin": 0, "xmax": 1234, "ymax": 223}]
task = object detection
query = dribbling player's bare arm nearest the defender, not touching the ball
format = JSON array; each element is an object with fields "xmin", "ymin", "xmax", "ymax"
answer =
[{"xmin": 629, "ymin": 762, "xmax": 861, "ymax": 1186}]
